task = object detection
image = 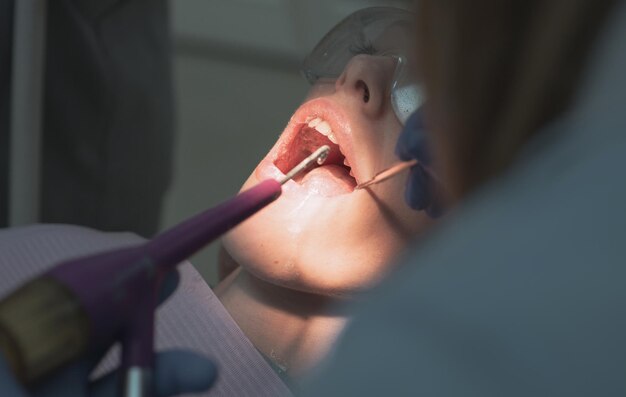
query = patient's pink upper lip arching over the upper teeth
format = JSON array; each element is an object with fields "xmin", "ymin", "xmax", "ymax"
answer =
[{"xmin": 272, "ymin": 98, "xmax": 360, "ymax": 183}]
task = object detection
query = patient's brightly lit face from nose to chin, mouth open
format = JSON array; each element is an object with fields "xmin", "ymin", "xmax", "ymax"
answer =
[{"xmin": 224, "ymin": 55, "xmax": 429, "ymax": 295}]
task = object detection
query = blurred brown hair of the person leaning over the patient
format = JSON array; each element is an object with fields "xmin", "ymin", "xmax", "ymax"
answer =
[{"xmin": 417, "ymin": 0, "xmax": 615, "ymax": 200}]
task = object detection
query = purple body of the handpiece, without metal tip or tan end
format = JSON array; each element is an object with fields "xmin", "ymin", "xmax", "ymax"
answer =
[{"xmin": 51, "ymin": 179, "xmax": 281, "ymax": 397}]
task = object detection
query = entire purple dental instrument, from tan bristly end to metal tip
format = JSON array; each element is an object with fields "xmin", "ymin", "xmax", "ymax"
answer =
[{"xmin": 0, "ymin": 146, "xmax": 330, "ymax": 397}]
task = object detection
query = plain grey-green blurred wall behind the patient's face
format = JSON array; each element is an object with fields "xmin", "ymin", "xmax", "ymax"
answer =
[{"xmin": 161, "ymin": 0, "xmax": 411, "ymax": 284}]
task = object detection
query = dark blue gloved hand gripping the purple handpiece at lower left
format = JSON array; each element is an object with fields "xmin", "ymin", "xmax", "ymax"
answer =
[{"xmin": 0, "ymin": 272, "xmax": 216, "ymax": 397}]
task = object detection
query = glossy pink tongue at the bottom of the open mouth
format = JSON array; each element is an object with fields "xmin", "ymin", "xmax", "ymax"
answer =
[{"xmin": 300, "ymin": 165, "xmax": 355, "ymax": 196}]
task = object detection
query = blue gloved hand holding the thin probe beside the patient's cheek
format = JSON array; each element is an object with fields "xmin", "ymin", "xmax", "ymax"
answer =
[{"xmin": 396, "ymin": 108, "xmax": 443, "ymax": 218}]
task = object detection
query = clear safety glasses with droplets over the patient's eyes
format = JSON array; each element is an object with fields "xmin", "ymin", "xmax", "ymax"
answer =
[{"xmin": 302, "ymin": 7, "xmax": 423, "ymax": 125}]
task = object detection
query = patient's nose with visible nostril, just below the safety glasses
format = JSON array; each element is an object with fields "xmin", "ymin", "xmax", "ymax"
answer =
[{"xmin": 335, "ymin": 55, "xmax": 396, "ymax": 118}]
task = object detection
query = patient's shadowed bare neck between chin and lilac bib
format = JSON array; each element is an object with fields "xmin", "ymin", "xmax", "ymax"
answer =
[{"xmin": 215, "ymin": 268, "xmax": 348, "ymax": 379}]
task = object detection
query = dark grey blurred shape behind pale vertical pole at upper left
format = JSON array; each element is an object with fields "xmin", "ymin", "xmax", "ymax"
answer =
[{"xmin": 0, "ymin": 0, "xmax": 174, "ymax": 237}]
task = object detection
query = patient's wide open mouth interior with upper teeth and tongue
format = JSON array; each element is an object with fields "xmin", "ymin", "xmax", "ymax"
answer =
[{"xmin": 274, "ymin": 117, "xmax": 357, "ymax": 196}]
